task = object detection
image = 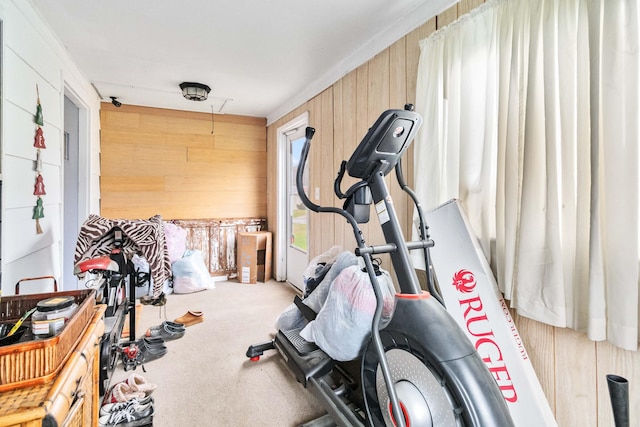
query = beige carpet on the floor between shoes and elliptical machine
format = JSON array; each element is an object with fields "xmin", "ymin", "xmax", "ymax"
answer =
[{"xmin": 111, "ymin": 281, "xmax": 324, "ymax": 427}]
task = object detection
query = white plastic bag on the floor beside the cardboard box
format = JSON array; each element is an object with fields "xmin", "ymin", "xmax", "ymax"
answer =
[{"xmin": 171, "ymin": 250, "xmax": 215, "ymax": 294}]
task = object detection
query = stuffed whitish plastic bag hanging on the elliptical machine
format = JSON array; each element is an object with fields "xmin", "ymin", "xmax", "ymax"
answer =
[{"xmin": 300, "ymin": 265, "xmax": 395, "ymax": 361}]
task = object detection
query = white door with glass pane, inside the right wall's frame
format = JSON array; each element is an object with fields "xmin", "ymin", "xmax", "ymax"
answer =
[{"xmin": 287, "ymin": 129, "xmax": 309, "ymax": 291}]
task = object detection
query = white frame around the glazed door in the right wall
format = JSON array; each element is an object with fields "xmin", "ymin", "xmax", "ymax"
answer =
[{"xmin": 275, "ymin": 111, "xmax": 309, "ymax": 282}]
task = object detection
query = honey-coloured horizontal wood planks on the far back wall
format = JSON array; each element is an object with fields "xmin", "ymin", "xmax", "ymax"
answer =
[{"xmin": 100, "ymin": 103, "xmax": 267, "ymax": 219}]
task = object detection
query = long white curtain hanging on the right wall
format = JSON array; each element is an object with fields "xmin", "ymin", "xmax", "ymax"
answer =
[{"xmin": 414, "ymin": 0, "xmax": 640, "ymax": 350}]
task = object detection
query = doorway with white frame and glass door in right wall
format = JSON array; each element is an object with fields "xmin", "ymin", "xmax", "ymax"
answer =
[{"xmin": 276, "ymin": 113, "xmax": 309, "ymax": 291}]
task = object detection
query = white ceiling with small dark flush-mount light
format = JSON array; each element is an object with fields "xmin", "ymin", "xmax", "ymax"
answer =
[{"xmin": 30, "ymin": 0, "xmax": 458, "ymax": 123}]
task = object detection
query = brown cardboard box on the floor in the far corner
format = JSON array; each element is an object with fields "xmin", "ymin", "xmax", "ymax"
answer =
[{"xmin": 236, "ymin": 231, "xmax": 271, "ymax": 283}]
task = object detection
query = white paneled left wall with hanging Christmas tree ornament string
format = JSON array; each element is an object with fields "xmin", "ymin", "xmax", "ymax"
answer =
[{"xmin": 0, "ymin": 0, "xmax": 100, "ymax": 295}]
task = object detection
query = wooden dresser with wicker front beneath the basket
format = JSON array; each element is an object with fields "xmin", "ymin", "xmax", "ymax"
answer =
[{"xmin": 0, "ymin": 304, "xmax": 106, "ymax": 427}]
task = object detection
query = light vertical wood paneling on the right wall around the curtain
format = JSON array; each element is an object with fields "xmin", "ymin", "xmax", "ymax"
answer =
[{"xmin": 267, "ymin": 0, "xmax": 640, "ymax": 427}]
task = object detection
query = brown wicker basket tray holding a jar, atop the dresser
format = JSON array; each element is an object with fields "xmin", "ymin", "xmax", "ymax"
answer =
[{"xmin": 0, "ymin": 289, "xmax": 95, "ymax": 392}]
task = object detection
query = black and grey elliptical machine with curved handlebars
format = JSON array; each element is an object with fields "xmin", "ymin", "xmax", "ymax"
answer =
[{"xmin": 247, "ymin": 105, "xmax": 514, "ymax": 427}]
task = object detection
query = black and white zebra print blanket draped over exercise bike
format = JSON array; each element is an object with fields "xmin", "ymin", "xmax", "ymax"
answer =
[{"xmin": 74, "ymin": 214, "xmax": 171, "ymax": 297}]
